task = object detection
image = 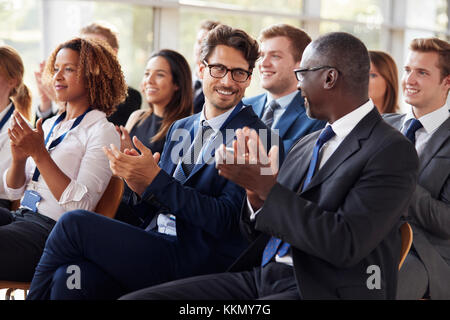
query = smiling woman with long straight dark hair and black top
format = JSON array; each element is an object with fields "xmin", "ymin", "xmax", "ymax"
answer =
[{"xmin": 116, "ymin": 49, "xmax": 193, "ymax": 225}]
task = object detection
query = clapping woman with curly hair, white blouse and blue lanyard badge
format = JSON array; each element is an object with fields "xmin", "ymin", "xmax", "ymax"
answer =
[{"xmin": 0, "ymin": 38, "xmax": 127, "ymax": 281}]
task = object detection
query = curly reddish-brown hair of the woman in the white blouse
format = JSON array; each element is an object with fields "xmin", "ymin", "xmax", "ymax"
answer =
[{"xmin": 44, "ymin": 38, "xmax": 128, "ymax": 116}]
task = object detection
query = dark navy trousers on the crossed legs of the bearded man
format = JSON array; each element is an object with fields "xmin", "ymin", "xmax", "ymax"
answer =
[{"xmin": 28, "ymin": 210, "xmax": 192, "ymax": 299}]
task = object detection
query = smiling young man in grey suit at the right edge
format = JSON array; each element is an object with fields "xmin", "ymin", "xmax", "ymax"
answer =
[{"xmin": 384, "ymin": 38, "xmax": 450, "ymax": 300}]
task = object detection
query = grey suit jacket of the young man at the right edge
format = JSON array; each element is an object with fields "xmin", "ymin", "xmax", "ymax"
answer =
[{"xmin": 384, "ymin": 114, "xmax": 450, "ymax": 299}]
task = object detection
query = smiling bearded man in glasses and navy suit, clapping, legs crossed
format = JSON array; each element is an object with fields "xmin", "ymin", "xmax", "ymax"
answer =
[{"xmin": 28, "ymin": 25, "xmax": 282, "ymax": 299}]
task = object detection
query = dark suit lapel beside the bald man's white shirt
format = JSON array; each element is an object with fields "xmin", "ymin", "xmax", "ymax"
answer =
[{"xmin": 304, "ymin": 109, "xmax": 381, "ymax": 191}]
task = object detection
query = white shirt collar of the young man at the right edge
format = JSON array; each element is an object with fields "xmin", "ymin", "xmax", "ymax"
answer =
[{"xmin": 401, "ymin": 103, "xmax": 450, "ymax": 154}]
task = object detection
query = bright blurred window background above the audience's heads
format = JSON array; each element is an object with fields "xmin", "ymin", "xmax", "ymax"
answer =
[{"xmin": 0, "ymin": 0, "xmax": 450, "ymax": 112}]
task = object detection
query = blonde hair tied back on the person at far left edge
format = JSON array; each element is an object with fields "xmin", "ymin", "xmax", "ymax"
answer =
[{"xmin": 0, "ymin": 46, "xmax": 33, "ymax": 121}]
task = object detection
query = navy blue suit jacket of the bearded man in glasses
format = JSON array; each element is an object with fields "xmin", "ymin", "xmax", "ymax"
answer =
[{"xmin": 137, "ymin": 107, "xmax": 283, "ymax": 275}]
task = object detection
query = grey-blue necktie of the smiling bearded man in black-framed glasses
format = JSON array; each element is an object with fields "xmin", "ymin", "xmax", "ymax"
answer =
[{"xmin": 173, "ymin": 125, "xmax": 214, "ymax": 182}]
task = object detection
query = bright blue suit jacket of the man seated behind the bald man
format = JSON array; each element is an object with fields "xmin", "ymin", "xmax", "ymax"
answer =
[{"xmin": 243, "ymin": 91, "xmax": 326, "ymax": 153}]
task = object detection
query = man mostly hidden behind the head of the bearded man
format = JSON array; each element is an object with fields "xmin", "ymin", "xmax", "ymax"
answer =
[{"xmin": 192, "ymin": 20, "xmax": 220, "ymax": 113}]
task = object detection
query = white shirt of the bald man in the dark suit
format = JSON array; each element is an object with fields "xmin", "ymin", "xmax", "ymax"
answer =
[{"xmin": 247, "ymin": 99, "xmax": 374, "ymax": 266}]
